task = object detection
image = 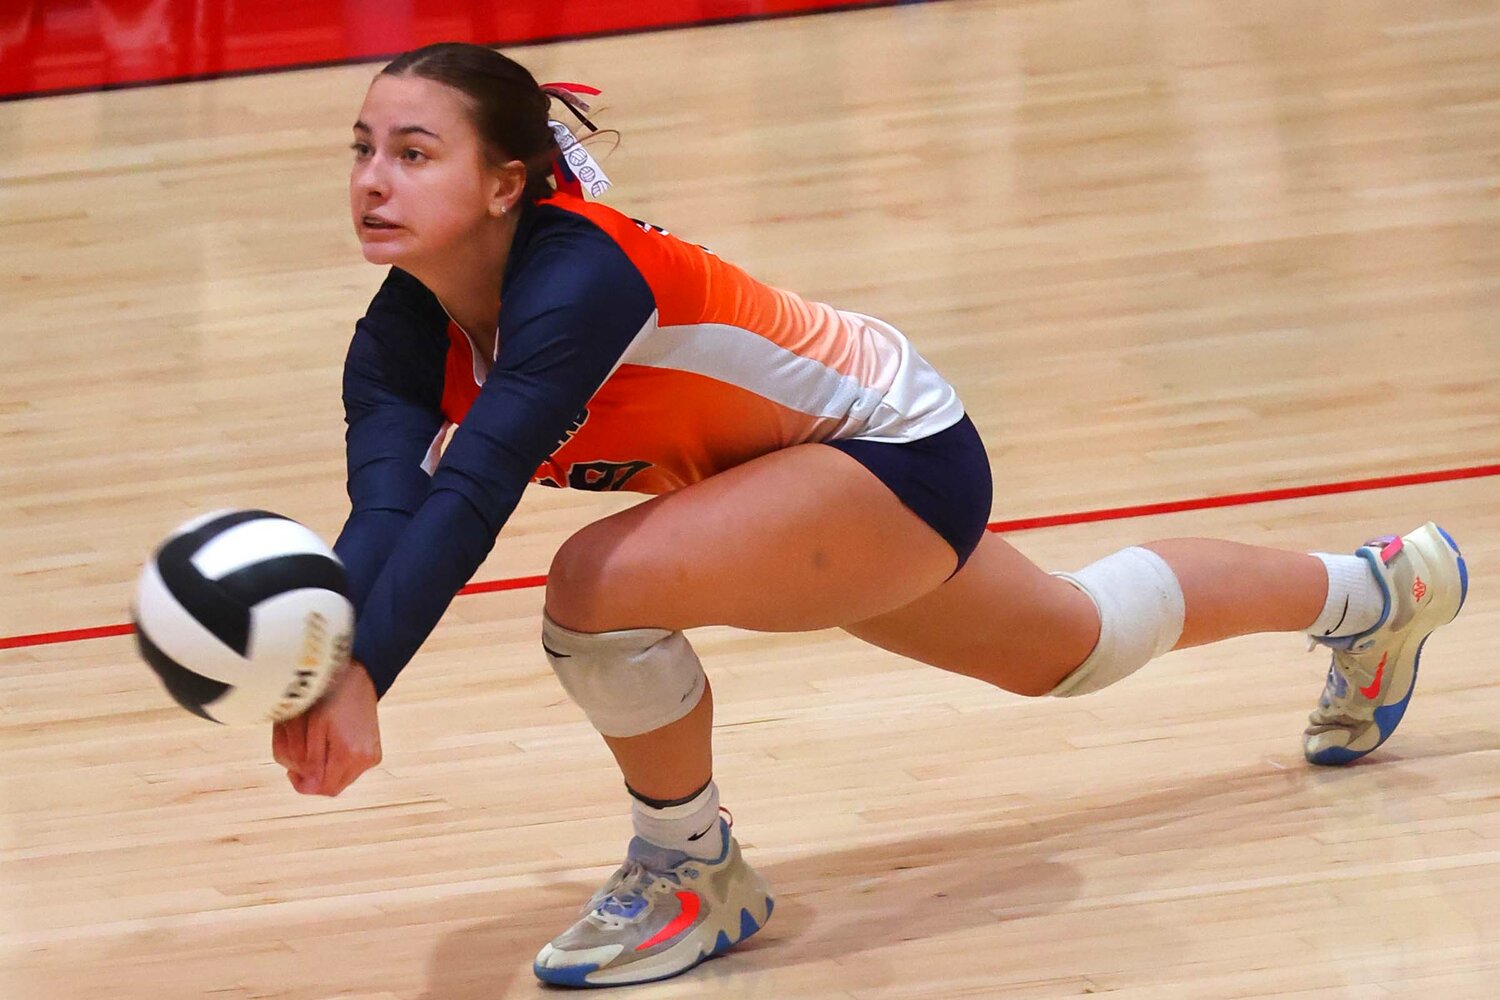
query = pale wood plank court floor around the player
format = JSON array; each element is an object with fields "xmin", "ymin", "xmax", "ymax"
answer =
[{"xmin": 0, "ymin": 0, "xmax": 1500, "ymax": 1000}]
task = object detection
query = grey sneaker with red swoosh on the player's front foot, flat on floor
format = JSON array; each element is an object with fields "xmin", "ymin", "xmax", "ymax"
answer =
[{"xmin": 533, "ymin": 817, "xmax": 776, "ymax": 987}]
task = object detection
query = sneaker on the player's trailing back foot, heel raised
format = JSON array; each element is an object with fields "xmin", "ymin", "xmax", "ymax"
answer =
[{"xmin": 1302, "ymin": 522, "xmax": 1469, "ymax": 765}]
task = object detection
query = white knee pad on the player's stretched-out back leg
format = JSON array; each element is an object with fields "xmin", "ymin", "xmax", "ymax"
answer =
[{"xmin": 1050, "ymin": 547, "xmax": 1184, "ymax": 697}]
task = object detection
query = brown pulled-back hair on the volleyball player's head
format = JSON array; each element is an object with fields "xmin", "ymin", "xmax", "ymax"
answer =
[{"xmin": 381, "ymin": 42, "xmax": 558, "ymax": 201}]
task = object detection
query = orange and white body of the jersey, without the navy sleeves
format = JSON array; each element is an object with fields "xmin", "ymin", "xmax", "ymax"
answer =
[{"xmin": 443, "ymin": 195, "xmax": 963, "ymax": 493}]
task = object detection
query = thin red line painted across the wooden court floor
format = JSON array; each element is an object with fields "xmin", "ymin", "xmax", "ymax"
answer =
[{"xmin": 0, "ymin": 463, "xmax": 1500, "ymax": 649}]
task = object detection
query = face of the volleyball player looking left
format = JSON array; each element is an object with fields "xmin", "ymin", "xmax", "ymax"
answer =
[{"xmin": 350, "ymin": 75, "xmax": 494, "ymax": 270}]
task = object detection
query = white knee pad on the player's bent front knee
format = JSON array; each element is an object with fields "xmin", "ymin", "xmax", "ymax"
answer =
[{"xmin": 542, "ymin": 612, "xmax": 708, "ymax": 736}]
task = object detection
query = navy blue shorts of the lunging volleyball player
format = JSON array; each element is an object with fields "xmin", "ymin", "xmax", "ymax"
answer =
[{"xmin": 824, "ymin": 414, "xmax": 995, "ymax": 573}]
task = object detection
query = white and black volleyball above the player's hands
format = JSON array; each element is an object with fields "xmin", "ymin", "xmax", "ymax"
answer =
[{"xmin": 132, "ymin": 510, "xmax": 354, "ymax": 726}]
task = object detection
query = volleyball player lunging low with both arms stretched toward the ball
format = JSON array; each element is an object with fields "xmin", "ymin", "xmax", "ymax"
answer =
[{"xmin": 273, "ymin": 43, "xmax": 1467, "ymax": 985}]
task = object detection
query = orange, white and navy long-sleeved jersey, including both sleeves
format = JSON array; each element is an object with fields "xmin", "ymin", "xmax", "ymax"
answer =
[{"xmin": 335, "ymin": 193, "xmax": 963, "ymax": 693}]
